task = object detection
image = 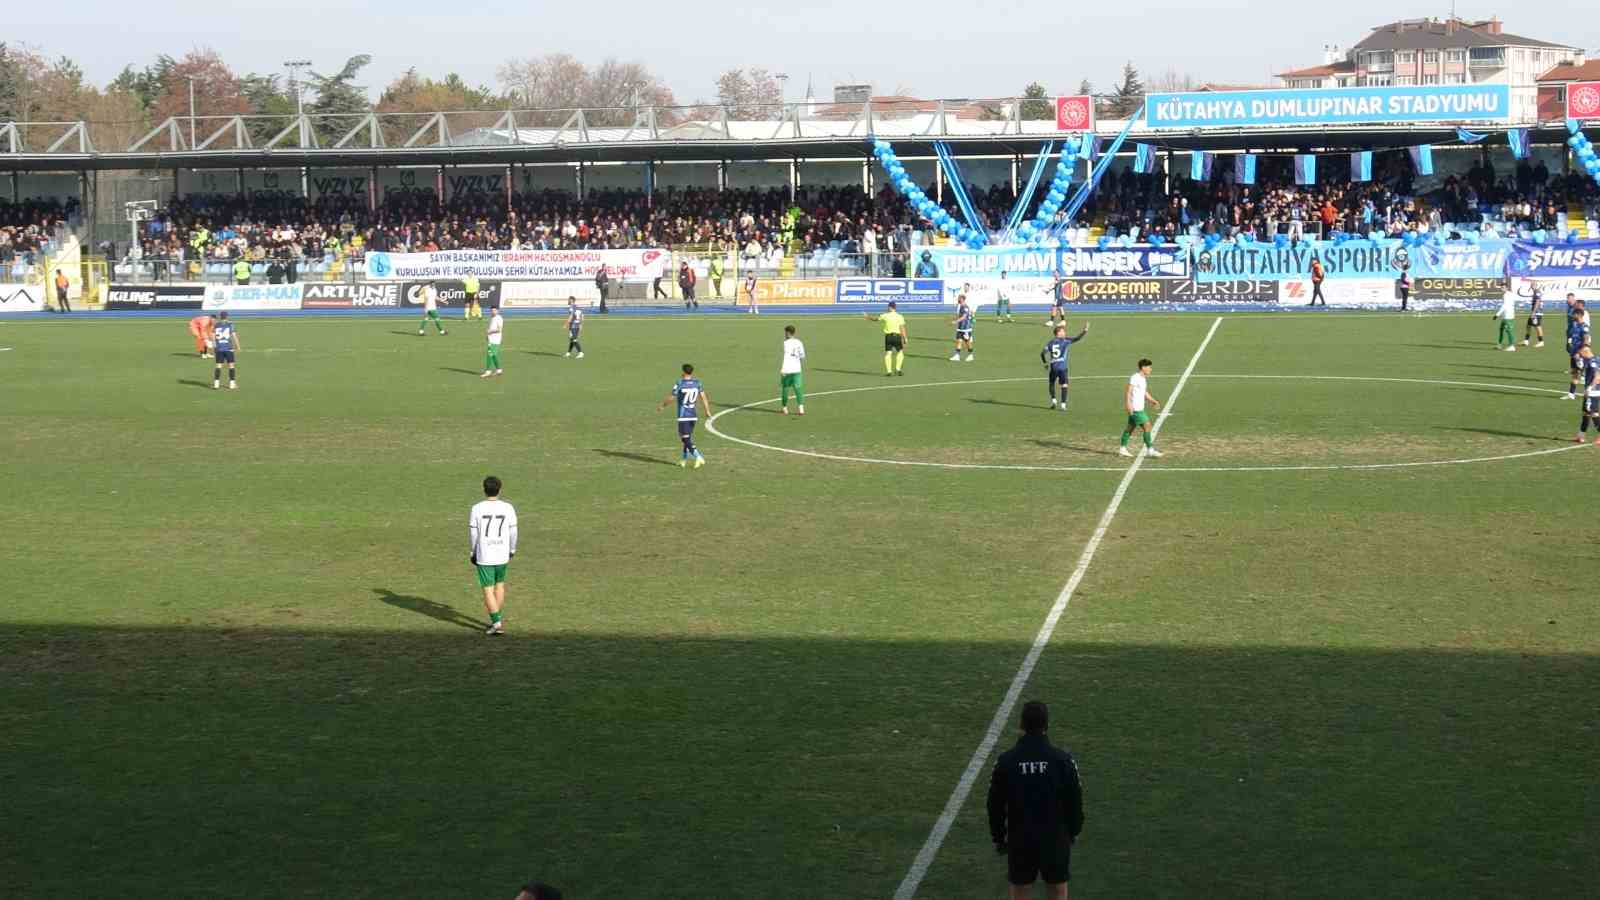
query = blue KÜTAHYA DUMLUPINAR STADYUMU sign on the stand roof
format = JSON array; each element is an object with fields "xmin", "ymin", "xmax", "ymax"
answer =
[{"xmin": 1144, "ymin": 85, "xmax": 1510, "ymax": 128}]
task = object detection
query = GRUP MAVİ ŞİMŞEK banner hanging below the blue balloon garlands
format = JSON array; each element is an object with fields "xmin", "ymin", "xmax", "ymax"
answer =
[{"xmin": 928, "ymin": 247, "xmax": 1189, "ymax": 282}]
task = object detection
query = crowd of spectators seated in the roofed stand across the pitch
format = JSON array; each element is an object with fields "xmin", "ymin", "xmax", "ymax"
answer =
[{"xmin": 103, "ymin": 151, "xmax": 1600, "ymax": 271}]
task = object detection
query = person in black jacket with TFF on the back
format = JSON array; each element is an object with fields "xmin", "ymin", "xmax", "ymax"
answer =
[{"xmin": 989, "ymin": 700, "xmax": 1083, "ymax": 900}]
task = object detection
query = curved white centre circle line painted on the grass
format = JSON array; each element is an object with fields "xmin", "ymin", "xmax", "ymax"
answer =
[{"xmin": 706, "ymin": 375, "xmax": 1581, "ymax": 472}]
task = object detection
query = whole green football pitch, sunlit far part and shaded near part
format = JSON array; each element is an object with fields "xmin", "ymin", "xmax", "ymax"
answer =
[{"xmin": 0, "ymin": 311, "xmax": 1600, "ymax": 900}]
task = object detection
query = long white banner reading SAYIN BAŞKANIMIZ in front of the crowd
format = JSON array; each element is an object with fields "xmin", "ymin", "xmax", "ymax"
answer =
[{"xmin": 365, "ymin": 250, "xmax": 669, "ymax": 282}]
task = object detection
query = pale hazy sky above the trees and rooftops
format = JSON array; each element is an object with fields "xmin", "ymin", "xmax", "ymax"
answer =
[{"xmin": 3, "ymin": 0, "xmax": 1600, "ymax": 102}]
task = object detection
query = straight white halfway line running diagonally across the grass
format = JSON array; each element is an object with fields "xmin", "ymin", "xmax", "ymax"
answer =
[{"xmin": 894, "ymin": 315, "xmax": 1222, "ymax": 900}]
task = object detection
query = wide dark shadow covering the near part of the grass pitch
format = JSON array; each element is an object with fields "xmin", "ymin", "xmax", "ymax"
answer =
[{"xmin": 0, "ymin": 624, "xmax": 1600, "ymax": 900}]
